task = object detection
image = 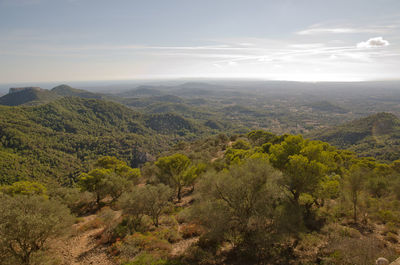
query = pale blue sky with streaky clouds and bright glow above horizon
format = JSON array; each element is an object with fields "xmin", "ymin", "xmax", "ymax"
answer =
[{"xmin": 0, "ymin": 0, "xmax": 400, "ymax": 83}]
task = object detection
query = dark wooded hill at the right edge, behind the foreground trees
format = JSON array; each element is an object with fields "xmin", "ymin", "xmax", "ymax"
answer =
[{"xmin": 308, "ymin": 112, "xmax": 400, "ymax": 161}]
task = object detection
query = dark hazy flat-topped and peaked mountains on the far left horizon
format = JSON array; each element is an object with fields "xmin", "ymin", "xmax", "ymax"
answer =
[{"xmin": 0, "ymin": 85, "xmax": 102, "ymax": 106}]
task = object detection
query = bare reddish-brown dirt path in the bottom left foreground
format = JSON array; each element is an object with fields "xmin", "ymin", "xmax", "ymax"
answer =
[{"xmin": 51, "ymin": 215, "xmax": 115, "ymax": 265}]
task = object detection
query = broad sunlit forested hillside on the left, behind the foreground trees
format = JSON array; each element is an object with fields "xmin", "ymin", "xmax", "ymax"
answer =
[{"xmin": 0, "ymin": 97, "xmax": 211, "ymax": 183}]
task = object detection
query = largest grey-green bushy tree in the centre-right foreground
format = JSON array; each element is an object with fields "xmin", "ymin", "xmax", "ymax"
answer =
[{"xmin": 191, "ymin": 159, "xmax": 284, "ymax": 260}]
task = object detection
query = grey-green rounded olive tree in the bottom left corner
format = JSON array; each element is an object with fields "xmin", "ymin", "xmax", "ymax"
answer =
[{"xmin": 0, "ymin": 194, "xmax": 73, "ymax": 265}]
